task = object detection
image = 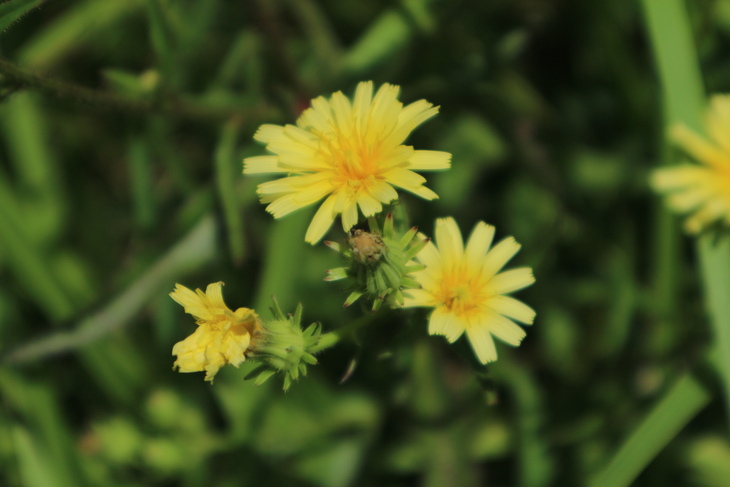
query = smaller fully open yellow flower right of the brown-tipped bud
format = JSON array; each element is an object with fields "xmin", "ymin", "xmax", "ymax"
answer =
[{"xmin": 405, "ymin": 218, "xmax": 535, "ymax": 364}]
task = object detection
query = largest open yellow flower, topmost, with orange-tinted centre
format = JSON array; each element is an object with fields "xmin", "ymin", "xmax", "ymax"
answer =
[{"xmin": 243, "ymin": 81, "xmax": 451, "ymax": 248}]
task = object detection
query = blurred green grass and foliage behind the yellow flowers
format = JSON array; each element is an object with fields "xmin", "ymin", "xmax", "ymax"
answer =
[{"xmin": 0, "ymin": 0, "xmax": 730, "ymax": 487}]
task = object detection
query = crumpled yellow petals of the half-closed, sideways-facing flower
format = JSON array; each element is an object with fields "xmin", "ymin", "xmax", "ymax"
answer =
[{"xmin": 170, "ymin": 282, "xmax": 261, "ymax": 381}]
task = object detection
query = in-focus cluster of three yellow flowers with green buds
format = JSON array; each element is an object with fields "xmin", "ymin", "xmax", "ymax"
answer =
[{"xmin": 171, "ymin": 82, "xmax": 535, "ymax": 389}]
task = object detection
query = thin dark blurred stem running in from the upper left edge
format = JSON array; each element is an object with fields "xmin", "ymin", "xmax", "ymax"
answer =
[{"xmin": 0, "ymin": 59, "xmax": 263, "ymax": 120}]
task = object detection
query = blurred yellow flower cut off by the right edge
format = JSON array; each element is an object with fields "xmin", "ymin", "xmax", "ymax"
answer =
[{"xmin": 651, "ymin": 95, "xmax": 730, "ymax": 234}]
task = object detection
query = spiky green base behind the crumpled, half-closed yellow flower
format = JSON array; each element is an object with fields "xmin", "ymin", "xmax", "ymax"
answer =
[{"xmin": 246, "ymin": 298, "xmax": 322, "ymax": 391}]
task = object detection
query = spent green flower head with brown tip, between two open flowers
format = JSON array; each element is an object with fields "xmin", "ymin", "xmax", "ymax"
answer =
[{"xmin": 325, "ymin": 213, "xmax": 430, "ymax": 313}]
